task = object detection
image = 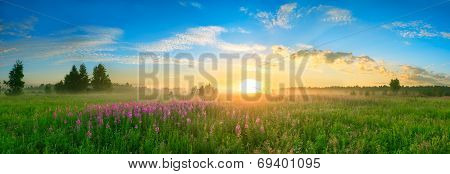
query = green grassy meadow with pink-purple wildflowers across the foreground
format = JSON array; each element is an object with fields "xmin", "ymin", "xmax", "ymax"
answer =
[{"xmin": 0, "ymin": 94, "xmax": 450, "ymax": 153}]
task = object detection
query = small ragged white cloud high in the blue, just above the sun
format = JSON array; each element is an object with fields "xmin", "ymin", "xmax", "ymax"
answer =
[{"xmin": 243, "ymin": 3, "xmax": 300, "ymax": 29}]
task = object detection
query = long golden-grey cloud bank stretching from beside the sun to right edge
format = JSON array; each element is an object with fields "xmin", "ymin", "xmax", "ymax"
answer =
[{"xmin": 290, "ymin": 50, "xmax": 450, "ymax": 85}]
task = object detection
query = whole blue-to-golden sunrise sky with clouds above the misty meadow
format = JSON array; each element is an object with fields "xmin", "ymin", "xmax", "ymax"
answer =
[{"xmin": 0, "ymin": 0, "xmax": 450, "ymax": 89}]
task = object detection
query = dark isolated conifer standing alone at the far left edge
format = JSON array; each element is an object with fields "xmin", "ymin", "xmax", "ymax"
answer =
[{"xmin": 3, "ymin": 60, "xmax": 25, "ymax": 95}]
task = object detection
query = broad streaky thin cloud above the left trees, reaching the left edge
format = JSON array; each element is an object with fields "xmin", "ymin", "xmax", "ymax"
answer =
[{"xmin": 0, "ymin": 26, "xmax": 123, "ymax": 62}]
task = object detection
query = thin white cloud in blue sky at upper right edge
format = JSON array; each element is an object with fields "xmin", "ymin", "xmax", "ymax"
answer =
[{"xmin": 382, "ymin": 20, "xmax": 450, "ymax": 39}]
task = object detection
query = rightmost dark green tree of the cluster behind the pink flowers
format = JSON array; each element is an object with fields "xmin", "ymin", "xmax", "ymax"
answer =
[{"xmin": 91, "ymin": 64, "xmax": 112, "ymax": 90}]
